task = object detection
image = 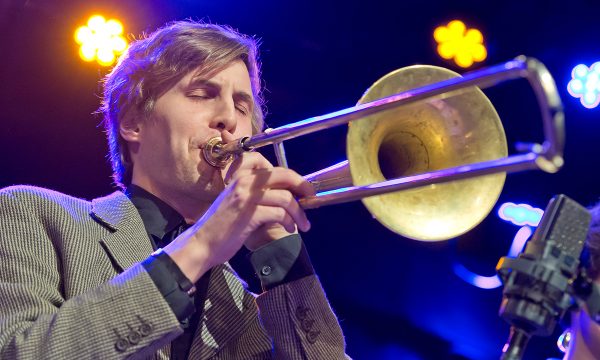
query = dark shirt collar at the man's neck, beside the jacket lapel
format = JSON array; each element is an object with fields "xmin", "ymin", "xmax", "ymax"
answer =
[{"xmin": 125, "ymin": 184, "xmax": 184, "ymax": 239}]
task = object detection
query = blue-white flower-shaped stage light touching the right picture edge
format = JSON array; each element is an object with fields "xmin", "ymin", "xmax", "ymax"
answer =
[{"xmin": 567, "ymin": 61, "xmax": 600, "ymax": 109}]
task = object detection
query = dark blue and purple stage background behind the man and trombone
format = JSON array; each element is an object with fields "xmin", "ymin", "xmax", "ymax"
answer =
[{"xmin": 0, "ymin": 0, "xmax": 600, "ymax": 359}]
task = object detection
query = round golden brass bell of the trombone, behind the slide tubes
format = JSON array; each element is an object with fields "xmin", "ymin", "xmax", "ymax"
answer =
[{"xmin": 346, "ymin": 65, "xmax": 508, "ymax": 241}]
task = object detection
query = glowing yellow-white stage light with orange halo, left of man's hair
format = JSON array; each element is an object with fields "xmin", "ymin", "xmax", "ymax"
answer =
[{"xmin": 75, "ymin": 15, "xmax": 127, "ymax": 66}]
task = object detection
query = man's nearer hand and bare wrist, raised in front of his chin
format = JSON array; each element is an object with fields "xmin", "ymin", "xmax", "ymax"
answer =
[{"xmin": 164, "ymin": 153, "xmax": 314, "ymax": 283}]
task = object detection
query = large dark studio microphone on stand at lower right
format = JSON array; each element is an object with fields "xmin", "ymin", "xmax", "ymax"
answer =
[{"xmin": 496, "ymin": 194, "xmax": 591, "ymax": 360}]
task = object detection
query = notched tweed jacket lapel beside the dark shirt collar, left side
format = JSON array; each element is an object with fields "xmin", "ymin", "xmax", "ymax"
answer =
[{"xmin": 90, "ymin": 191, "xmax": 153, "ymax": 272}]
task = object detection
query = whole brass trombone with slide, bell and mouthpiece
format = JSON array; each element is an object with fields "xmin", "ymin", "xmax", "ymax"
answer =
[{"xmin": 203, "ymin": 56, "xmax": 564, "ymax": 241}]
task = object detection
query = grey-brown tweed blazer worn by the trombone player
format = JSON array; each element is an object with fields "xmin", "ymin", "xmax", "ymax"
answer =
[{"xmin": 0, "ymin": 186, "xmax": 346, "ymax": 359}]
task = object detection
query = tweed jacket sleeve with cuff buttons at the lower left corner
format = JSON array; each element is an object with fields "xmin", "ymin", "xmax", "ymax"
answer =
[{"xmin": 0, "ymin": 192, "xmax": 181, "ymax": 359}]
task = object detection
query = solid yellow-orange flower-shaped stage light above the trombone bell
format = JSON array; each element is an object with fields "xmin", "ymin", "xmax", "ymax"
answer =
[{"xmin": 433, "ymin": 20, "xmax": 487, "ymax": 68}]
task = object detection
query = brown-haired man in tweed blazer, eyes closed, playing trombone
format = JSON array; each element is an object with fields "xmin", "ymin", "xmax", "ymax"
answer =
[{"xmin": 0, "ymin": 21, "xmax": 346, "ymax": 359}]
